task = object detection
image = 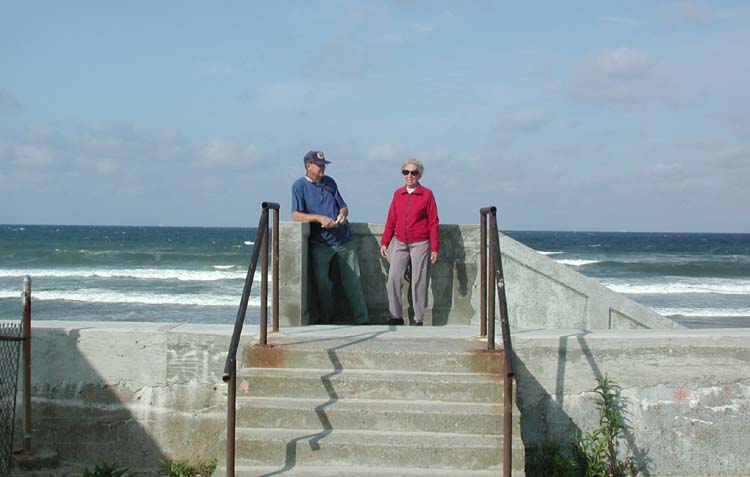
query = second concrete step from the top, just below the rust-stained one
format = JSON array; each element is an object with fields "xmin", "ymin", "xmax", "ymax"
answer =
[{"xmin": 237, "ymin": 368, "xmax": 503, "ymax": 404}]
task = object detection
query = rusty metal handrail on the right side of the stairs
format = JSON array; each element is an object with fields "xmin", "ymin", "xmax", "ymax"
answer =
[{"xmin": 479, "ymin": 206, "xmax": 515, "ymax": 477}]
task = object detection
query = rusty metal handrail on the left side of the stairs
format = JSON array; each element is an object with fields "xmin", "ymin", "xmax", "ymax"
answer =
[{"xmin": 221, "ymin": 202, "xmax": 279, "ymax": 477}]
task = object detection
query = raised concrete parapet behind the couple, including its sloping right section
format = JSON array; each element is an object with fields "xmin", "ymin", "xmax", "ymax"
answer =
[{"xmin": 279, "ymin": 222, "xmax": 679, "ymax": 329}]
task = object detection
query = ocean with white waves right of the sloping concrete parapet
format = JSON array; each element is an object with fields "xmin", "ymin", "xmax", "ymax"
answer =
[{"xmin": 508, "ymin": 232, "xmax": 750, "ymax": 326}]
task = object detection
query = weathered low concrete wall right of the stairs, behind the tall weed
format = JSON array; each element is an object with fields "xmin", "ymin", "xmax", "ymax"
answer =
[{"xmin": 513, "ymin": 330, "xmax": 750, "ymax": 476}]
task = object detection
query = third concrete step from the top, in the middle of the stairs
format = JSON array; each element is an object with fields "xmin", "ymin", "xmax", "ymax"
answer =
[{"xmin": 237, "ymin": 397, "xmax": 520, "ymax": 435}]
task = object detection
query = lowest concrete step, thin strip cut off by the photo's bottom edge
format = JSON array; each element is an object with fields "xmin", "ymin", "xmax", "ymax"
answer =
[{"xmin": 214, "ymin": 465, "xmax": 523, "ymax": 477}]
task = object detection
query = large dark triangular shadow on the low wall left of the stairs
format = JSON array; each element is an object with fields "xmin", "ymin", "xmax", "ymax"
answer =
[{"xmin": 13, "ymin": 329, "xmax": 170, "ymax": 475}]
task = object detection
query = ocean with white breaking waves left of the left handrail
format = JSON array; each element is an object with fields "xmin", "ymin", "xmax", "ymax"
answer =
[{"xmin": 0, "ymin": 225, "xmax": 258, "ymax": 323}]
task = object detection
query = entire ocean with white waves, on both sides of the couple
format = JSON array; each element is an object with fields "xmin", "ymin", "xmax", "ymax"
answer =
[{"xmin": 0, "ymin": 225, "xmax": 750, "ymax": 328}]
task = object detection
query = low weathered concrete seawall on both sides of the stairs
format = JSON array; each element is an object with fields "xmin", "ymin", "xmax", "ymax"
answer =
[{"xmin": 17, "ymin": 322, "xmax": 750, "ymax": 476}]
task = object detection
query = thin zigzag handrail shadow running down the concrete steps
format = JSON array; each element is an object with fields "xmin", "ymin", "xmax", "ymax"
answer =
[{"xmin": 260, "ymin": 330, "xmax": 390, "ymax": 477}]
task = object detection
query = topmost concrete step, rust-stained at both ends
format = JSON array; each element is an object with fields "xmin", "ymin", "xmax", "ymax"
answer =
[{"xmin": 243, "ymin": 338, "xmax": 504, "ymax": 374}]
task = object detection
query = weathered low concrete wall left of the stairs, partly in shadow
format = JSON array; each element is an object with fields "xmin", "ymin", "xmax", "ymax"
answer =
[{"xmin": 11, "ymin": 322, "xmax": 245, "ymax": 469}]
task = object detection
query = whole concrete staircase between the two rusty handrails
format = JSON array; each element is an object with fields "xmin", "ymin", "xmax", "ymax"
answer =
[{"xmin": 215, "ymin": 328, "xmax": 524, "ymax": 477}]
